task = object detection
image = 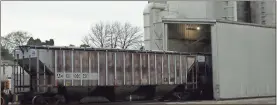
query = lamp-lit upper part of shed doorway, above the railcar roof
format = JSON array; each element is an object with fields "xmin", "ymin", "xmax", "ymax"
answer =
[{"xmin": 167, "ymin": 24, "xmax": 211, "ymax": 53}]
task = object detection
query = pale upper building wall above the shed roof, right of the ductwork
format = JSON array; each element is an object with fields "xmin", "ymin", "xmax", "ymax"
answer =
[{"xmin": 167, "ymin": 0, "xmax": 276, "ymax": 25}]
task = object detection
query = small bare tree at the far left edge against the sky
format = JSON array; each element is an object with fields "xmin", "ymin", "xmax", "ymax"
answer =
[{"xmin": 1, "ymin": 31, "xmax": 31, "ymax": 52}]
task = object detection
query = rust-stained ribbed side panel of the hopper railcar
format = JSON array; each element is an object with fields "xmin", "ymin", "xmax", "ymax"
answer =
[{"xmin": 15, "ymin": 49, "xmax": 196, "ymax": 86}]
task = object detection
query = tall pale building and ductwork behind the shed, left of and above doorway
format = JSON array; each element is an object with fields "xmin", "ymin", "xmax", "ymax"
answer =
[{"xmin": 144, "ymin": 0, "xmax": 276, "ymax": 51}]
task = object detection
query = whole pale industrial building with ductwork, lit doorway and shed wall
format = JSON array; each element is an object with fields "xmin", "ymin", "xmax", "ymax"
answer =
[{"xmin": 143, "ymin": 0, "xmax": 276, "ymax": 100}]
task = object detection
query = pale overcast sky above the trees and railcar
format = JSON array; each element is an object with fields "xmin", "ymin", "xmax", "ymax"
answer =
[{"xmin": 1, "ymin": 1, "xmax": 147, "ymax": 46}]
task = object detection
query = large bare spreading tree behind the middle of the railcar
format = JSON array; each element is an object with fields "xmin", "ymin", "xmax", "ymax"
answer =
[{"xmin": 82, "ymin": 22, "xmax": 142, "ymax": 49}]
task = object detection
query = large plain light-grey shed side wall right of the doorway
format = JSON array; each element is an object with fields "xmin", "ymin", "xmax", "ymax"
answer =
[{"xmin": 212, "ymin": 22, "xmax": 276, "ymax": 99}]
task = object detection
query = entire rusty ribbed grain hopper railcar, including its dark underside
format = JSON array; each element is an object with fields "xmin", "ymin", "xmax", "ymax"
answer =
[{"xmin": 9, "ymin": 46, "xmax": 211, "ymax": 104}]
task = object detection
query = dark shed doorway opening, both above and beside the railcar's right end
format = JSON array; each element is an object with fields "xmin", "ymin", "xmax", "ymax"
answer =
[{"xmin": 167, "ymin": 23, "xmax": 214, "ymax": 100}]
